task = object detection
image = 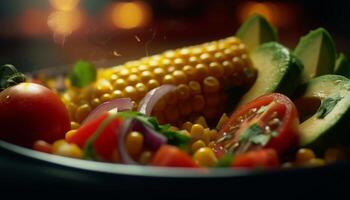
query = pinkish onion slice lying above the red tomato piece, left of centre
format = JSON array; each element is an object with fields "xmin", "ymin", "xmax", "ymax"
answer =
[{"xmin": 81, "ymin": 98, "xmax": 132, "ymax": 124}]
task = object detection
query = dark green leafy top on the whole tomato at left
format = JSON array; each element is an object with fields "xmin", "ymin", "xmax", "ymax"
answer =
[{"xmin": 0, "ymin": 64, "xmax": 25, "ymax": 92}]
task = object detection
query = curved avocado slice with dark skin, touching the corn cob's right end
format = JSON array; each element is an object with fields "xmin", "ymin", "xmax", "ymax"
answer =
[{"xmin": 239, "ymin": 42, "xmax": 303, "ymax": 105}]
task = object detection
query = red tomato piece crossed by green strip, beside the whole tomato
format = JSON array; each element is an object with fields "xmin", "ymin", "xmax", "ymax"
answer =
[{"xmin": 67, "ymin": 113, "xmax": 122, "ymax": 161}]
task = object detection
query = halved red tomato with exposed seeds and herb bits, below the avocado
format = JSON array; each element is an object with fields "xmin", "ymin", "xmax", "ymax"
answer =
[{"xmin": 213, "ymin": 93, "xmax": 299, "ymax": 157}]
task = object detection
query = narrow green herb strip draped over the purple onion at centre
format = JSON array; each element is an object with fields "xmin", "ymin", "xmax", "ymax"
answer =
[{"xmin": 118, "ymin": 111, "xmax": 191, "ymax": 148}]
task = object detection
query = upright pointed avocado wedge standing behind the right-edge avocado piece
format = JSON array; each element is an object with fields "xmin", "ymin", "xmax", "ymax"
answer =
[{"xmin": 294, "ymin": 28, "xmax": 336, "ymax": 83}]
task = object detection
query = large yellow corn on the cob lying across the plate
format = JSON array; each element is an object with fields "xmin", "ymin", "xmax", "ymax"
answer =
[{"xmin": 63, "ymin": 37, "xmax": 255, "ymax": 125}]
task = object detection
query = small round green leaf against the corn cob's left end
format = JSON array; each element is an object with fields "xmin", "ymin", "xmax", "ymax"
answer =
[{"xmin": 69, "ymin": 60, "xmax": 97, "ymax": 87}]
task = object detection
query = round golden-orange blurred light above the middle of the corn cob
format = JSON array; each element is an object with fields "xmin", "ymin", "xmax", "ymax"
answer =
[{"xmin": 111, "ymin": 1, "xmax": 151, "ymax": 29}]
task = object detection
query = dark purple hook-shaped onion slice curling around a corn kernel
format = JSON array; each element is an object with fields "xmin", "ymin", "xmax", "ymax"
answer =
[{"xmin": 117, "ymin": 119, "xmax": 167, "ymax": 164}]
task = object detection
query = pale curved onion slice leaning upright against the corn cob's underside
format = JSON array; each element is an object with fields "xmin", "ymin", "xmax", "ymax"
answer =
[{"xmin": 137, "ymin": 84, "xmax": 176, "ymax": 116}]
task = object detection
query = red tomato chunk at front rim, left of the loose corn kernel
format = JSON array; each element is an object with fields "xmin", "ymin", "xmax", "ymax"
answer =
[{"xmin": 151, "ymin": 145, "xmax": 198, "ymax": 167}]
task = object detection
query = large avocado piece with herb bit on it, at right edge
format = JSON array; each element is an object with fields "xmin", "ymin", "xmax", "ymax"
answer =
[{"xmin": 295, "ymin": 75, "xmax": 350, "ymax": 155}]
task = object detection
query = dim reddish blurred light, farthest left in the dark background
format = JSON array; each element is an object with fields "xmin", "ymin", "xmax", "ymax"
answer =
[{"xmin": 18, "ymin": 9, "xmax": 47, "ymax": 36}]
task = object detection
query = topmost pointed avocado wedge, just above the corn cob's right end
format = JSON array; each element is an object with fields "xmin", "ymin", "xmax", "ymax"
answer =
[{"xmin": 236, "ymin": 14, "xmax": 277, "ymax": 51}]
